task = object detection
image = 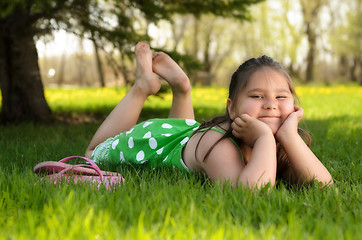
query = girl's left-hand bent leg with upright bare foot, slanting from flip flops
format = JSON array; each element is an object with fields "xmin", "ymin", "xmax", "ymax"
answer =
[{"xmin": 86, "ymin": 42, "xmax": 161, "ymax": 157}]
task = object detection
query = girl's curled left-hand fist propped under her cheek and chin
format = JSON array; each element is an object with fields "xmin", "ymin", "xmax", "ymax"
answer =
[{"xmin": 231, "ymin": 114, "xmax": 273, "ymax": 147}]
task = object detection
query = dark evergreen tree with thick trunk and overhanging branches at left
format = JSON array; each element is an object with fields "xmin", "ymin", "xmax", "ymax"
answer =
[{"xmin": 0, "ymin": 0, "xmax": 260, "ymax": 121}]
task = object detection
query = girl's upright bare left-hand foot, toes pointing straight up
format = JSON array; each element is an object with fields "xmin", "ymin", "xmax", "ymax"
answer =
[{"xmin": 134, "ymin": 42, "xmax": 161, "ymax": 95}]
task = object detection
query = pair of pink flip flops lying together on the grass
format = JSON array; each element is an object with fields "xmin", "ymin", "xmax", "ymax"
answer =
[{"xmin": 34, "ymin": 156, "xmax": 124, "ymax": 190}]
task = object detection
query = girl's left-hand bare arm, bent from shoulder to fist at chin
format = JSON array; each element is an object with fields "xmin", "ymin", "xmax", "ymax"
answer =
[{"xmin": 195, "ymin": 115, "xmax": 276, "ymax": 189}]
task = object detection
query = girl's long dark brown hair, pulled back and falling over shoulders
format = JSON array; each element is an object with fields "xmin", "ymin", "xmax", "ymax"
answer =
[{"xmin": 194, "ymin": 55, "xmax": 311, "ymax": 176}]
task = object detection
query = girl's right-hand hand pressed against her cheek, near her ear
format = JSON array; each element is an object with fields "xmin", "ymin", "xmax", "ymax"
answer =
[{"xmin": 275, "ymin": 106, "xmax": 304, "ymax": 141}]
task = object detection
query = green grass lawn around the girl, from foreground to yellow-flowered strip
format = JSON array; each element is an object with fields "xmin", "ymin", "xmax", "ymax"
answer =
[{"xmin": 0, "ymin": 87, "xmax": 362, "ymax": 239}]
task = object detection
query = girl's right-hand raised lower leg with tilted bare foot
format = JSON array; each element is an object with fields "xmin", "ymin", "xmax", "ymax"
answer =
[{"xmin": 152, "ymin": 52, "xmax": 195, "ymax": 119}]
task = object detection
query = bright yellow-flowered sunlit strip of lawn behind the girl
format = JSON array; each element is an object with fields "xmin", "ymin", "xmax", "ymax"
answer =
[{"xmin": 45, "ymin": 86, "xmax": 362, "ymax": 119}]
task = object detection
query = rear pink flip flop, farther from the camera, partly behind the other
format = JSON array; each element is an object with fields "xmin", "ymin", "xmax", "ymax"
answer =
[{"xmin": 34, "ymin": 156, "xmax": 119, "ymax": 176}]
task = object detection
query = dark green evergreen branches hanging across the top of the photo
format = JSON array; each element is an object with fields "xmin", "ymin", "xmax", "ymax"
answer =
[{"xmin": 0, "ymin": 0, "xmax": 261, "ymax": 56}]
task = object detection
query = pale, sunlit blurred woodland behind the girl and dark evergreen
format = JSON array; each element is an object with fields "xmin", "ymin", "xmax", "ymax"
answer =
[{"xmin": 38, "ymin": 0, "xmax": 362, "ymax": 89}]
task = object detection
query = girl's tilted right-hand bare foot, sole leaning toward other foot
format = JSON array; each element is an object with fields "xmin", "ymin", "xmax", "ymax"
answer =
[{"xmin": 152, "ymin": 52, "xmax": 191, "ymax": 93}]
